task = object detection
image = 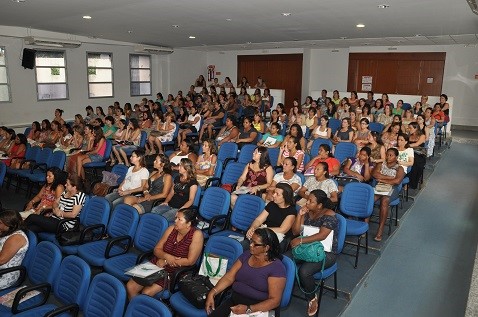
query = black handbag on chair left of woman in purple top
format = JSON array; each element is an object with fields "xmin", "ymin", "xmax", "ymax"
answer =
[{"xmin": 178, "ymin": 272, "xmax": 214, "ymax": 308}]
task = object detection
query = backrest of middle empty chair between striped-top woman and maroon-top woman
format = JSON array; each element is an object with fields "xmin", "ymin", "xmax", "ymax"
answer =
[{"xmin": 107, "ymin": 204, "xmax": 139, "ymax": 238}]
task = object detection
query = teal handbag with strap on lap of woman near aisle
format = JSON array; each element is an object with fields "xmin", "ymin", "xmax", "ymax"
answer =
[{"xmin": 292, "ymin": 236, "xmax": 326, "ymax": 294}]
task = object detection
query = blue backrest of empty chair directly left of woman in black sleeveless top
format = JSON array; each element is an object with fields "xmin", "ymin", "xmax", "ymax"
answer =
[{"xmin": 231, "ymin": 194, "xmax": 265, "ymax": 231}]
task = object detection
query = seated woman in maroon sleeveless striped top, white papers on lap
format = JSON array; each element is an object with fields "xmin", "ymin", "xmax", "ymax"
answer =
[{"xmin": 126, "ymin": 208, "xmax": 204, "ymax": 299}]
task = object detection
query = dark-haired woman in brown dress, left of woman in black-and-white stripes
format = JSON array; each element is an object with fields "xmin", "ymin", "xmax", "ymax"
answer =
[{"xmin": 20, "ymin": 167, "xmax": 66, "ymax": 219}]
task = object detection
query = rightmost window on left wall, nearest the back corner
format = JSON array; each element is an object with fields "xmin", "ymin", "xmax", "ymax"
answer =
[{"xmin": 129, "ymin": 54, "xmax": 151, "ymax": 96}]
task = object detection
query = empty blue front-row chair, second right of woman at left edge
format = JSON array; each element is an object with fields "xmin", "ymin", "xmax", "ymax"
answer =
[{"xmin": 15, "ymin": 255, "xmax": 91, "ymax": 317}]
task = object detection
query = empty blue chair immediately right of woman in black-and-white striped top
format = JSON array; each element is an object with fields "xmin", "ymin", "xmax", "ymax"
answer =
[{"xmin": 58, "ymin": 196, "xmax": 110, "ymax": 254}]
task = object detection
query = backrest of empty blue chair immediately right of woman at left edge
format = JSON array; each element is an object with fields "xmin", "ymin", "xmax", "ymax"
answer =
[{"xmin": 27, "ymin": 241, "xmax": 62, "ymax": 285}]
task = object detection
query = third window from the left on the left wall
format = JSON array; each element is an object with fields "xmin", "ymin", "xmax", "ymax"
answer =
[{"xmin": 87, "ymin": 53, "xmax": 113, "ymax": 98}]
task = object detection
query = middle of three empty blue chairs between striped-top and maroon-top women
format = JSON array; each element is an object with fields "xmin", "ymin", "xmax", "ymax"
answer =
[{"xmin": 78, "ymin": 204, "xmax": 139, "ymax": 267}]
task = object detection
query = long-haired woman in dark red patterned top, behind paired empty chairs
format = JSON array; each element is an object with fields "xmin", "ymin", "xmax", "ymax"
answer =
[{"xmin": 231, "ymin": 146, "xmax": 274, "ymax": 208}]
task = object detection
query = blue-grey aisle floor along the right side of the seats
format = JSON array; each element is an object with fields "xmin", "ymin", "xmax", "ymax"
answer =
[{"xmin": 342, "ymin": 143, "xmax": 478, "ymax": 317}]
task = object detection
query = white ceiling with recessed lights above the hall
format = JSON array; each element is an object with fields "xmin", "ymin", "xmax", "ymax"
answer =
[{"xmin": 0, "ymin": 0, "xmax": 478, "ymax": 51}]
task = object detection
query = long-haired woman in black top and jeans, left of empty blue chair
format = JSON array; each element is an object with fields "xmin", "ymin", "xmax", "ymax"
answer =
[{"xmin": 151, "ymin": 158, "xmax": 198, "ymax": 221}]
